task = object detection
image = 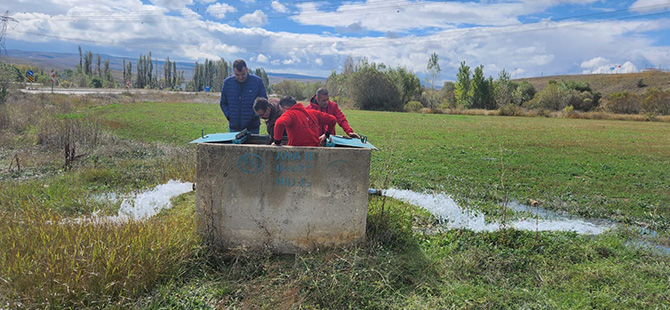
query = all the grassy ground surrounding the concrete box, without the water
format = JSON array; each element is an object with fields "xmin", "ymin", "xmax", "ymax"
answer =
[{"xmin": 0, "ymin": 95, "xmax": 670, "ymax": 309}]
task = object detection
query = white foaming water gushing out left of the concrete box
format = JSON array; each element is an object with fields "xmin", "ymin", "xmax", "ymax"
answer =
[{"xmin": 88, "ymin": 180, "xmax": 193, "ymax": 222}]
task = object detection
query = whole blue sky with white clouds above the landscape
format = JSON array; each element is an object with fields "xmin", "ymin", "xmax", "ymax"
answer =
[{"xmin": 0, "ymin": 0, "xmax": 670, "ymax": 81}]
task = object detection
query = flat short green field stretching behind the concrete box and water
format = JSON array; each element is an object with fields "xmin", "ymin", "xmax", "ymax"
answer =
[{"xmin": 91, "ymin": 103, "xmax": 670, "ymax": 229}]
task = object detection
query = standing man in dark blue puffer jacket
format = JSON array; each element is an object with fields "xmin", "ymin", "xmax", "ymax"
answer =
[{"xmin": 219, "ymin": 59, "xmax": 268, "ymax": 134}]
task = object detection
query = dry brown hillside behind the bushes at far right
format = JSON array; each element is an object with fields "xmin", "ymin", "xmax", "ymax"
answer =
[{"xmin": 515, "ymin": 72, "xmax": 670, "ymax": 97}]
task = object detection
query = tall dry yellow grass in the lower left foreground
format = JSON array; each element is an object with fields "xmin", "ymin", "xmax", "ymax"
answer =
[{"xmin": 0, "ymin": 200, "xmax": 199, "ymax": 309}]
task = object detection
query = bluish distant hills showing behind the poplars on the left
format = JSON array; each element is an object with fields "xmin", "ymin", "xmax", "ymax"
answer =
[{"xmin": 7, "ymin": 50, "xmax": 326, "ymax": 84}]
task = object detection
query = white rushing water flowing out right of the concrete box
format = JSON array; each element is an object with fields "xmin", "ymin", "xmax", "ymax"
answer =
[{"xmin": 383, "ymin": 189, "xmax": 615, "ymax": 235}]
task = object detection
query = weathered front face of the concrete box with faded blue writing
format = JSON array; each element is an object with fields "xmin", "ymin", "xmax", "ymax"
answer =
[{"xmin": 196, "ymin": 143, "xmax": 371, "ymax": 253}]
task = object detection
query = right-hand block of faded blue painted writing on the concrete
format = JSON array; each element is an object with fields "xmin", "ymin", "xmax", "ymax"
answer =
[{"xmin": 275, "ymin": 151, "xmax": 314, "ymax": 188}]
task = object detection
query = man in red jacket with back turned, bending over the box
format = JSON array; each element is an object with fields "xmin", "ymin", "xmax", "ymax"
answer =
[{"xmin": 272, "ymin": 96, "xmax": 337, "ymax": 146}]
